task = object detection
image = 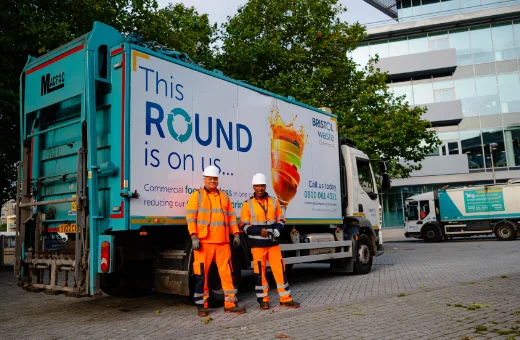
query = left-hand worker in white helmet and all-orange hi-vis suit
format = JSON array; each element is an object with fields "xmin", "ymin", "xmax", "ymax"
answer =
[{"xmin": 186, "ymin": 165, "xmax": 246, "ymax": 316}]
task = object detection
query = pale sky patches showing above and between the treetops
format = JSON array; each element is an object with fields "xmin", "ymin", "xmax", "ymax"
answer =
[{"xmin": 157, "ymin": 0, "xmax": 389, "ymax": 25}]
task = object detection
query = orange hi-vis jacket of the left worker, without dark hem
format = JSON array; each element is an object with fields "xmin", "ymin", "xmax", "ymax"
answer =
[{"xmin": 186, "ymin": 187, "xmax": 240, "ymax": 243}]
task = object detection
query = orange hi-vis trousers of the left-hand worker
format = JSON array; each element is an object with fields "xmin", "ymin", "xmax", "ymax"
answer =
[{"xmin": 193, "ymin": 243, "xmax": 237, "ymax": 308}]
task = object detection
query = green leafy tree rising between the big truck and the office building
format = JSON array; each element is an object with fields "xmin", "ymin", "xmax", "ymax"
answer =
[{"xmin": 218, "ymin": 0, "xmax": 439, "ymax": 177}]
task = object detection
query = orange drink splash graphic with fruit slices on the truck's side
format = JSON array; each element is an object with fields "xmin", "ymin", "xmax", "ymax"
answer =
[{"xmin": 269, "ymin": 108, "xmax": 307, "ymax": 208}]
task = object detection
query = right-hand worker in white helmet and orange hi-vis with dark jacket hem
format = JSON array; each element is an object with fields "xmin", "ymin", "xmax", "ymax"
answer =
[{"xmin": 240, "ymin": 173, "xmax": 300, "ymax": 309}]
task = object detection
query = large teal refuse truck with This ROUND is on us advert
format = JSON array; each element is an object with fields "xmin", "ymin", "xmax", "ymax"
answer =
[{"xmin": 15, "ymin": 22, "xmax": 390, "ymax": 302}]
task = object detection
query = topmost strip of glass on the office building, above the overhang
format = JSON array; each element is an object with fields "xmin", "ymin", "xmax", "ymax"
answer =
[{"xmin": 397, "ymin": 0, "xmax": 520, "ymax": 22}]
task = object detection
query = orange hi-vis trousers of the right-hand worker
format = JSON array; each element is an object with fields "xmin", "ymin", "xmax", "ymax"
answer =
[{"xmin": 251, "ymin": 245, "xmax": 292, "ymax": 303}]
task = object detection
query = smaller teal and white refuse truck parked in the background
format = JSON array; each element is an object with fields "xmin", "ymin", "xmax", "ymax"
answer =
[{"xmin": 405, "ymin": 180, "xmax": 520, "ymax": 242}]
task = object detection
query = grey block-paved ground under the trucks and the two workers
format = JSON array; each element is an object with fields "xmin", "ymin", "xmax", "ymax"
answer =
[{"xmin": 0, "ymin": 238, "xmax": 520, "ymax": 340}]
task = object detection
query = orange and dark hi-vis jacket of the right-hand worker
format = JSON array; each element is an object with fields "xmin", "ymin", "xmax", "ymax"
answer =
[{"xmin": 240, "ymin": 193, "xmax": 285, "ymax": 247}]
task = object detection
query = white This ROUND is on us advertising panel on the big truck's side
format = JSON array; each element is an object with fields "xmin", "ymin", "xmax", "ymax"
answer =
[{"xmin": 129, "ymin": 49, "xmax": 342, "ymax": 224}]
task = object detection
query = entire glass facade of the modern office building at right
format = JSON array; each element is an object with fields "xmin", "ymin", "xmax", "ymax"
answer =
[{"xmin": 360, "ymin": 0, "xmax": 520, "ymax": 227}]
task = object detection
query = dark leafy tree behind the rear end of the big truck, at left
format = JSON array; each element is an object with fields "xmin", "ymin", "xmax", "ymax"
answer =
[{"xmin": 0, "ymin": 0, "xmax": 214, "ymax": 205}]
